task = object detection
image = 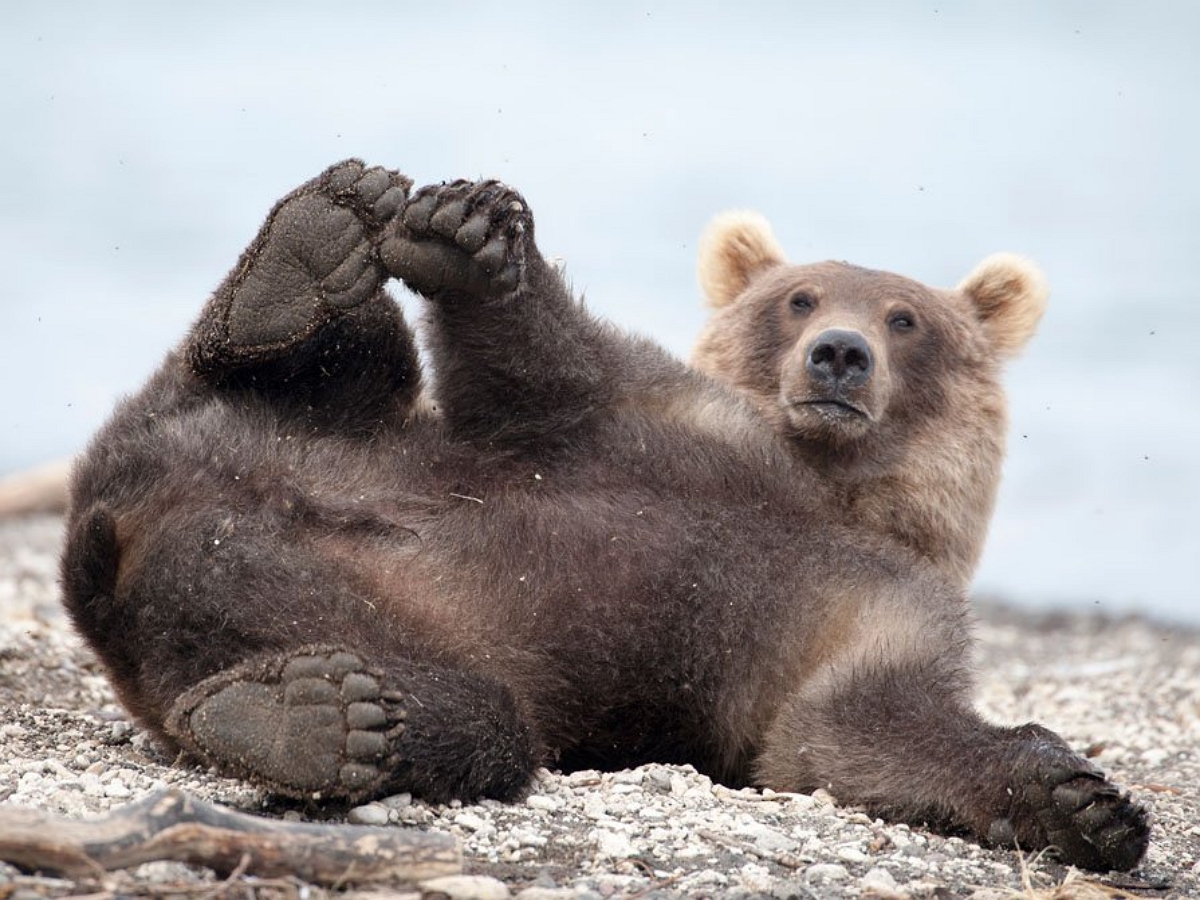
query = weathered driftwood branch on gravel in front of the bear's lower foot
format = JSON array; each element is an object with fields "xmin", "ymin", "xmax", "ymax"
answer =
[{"xmin": 0, "ymin": 790, "xmax": 462, "ymax": 884}]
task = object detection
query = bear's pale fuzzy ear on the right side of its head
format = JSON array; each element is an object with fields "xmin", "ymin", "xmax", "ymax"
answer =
[{"xmin": 959, "ymin": 253, "xmax": 1049, "ymax": 358}]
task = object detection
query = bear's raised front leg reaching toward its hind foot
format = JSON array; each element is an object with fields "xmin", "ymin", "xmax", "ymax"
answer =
[{"xmin": 382, "ymin": 181, "xmax": 628, "ymax": 443}]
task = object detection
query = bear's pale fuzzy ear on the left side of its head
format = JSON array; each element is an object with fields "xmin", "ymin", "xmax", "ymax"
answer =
[{"xmin": 700, "ymin": 211, "xmax": 787, "ymax": 308}]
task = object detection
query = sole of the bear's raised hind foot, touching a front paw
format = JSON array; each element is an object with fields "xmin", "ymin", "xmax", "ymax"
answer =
[{"xmin": 193, "ymin": 160, "xmax": 412, "ymax": 371}]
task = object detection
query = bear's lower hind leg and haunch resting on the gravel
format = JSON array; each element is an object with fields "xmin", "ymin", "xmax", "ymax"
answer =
[{"xmin": 62, "ymin": 504, "xmax": 541, "ymax": 800}]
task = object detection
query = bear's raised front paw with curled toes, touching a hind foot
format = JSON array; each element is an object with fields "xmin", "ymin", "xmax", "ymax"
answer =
[{"xmin": 380, "ymin": 181, "xmax": 533, "ymax": 296}]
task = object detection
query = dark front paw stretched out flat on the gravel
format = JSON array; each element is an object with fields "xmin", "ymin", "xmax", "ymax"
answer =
[{"xmin": 989, "ymin": 732, "xmax": 1150, "ymax": 871}]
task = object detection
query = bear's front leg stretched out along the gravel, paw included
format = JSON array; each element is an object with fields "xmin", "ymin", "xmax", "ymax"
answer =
[{"xmin": 758, "ymin": 660, "xmax": 1150, "ymax": 870}]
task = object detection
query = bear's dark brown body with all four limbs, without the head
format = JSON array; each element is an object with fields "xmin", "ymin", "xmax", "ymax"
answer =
[{"xmin": 62, "ymin": 161, "xmax": 1148, "ymax": 869}]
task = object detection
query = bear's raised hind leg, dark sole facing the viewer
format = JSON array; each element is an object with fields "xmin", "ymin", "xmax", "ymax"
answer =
[{"xmin": 185, "ymin": 160, "xmax": 420, "ymax": 431}]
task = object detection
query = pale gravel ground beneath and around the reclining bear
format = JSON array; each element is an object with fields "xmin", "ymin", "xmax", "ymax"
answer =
[{"xmin": 0, "ymin": 516, "xmax": 1200, "ymax": 900}]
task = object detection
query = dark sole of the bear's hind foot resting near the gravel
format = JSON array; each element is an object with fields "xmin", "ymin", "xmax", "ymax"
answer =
[{"xmin": 167, "ymin": 648, "xmax": 404, "ymax": 799}]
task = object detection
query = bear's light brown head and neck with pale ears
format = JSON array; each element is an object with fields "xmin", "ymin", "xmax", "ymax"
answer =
[{"xmin": 691, "ymin": 212, "xmax": 1046, "ymax": 588}]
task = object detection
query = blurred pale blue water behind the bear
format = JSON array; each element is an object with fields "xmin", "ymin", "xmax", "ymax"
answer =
[{"xmin": 0, "ymin": 0, "xmax": 1200, "ymax": 623}]
